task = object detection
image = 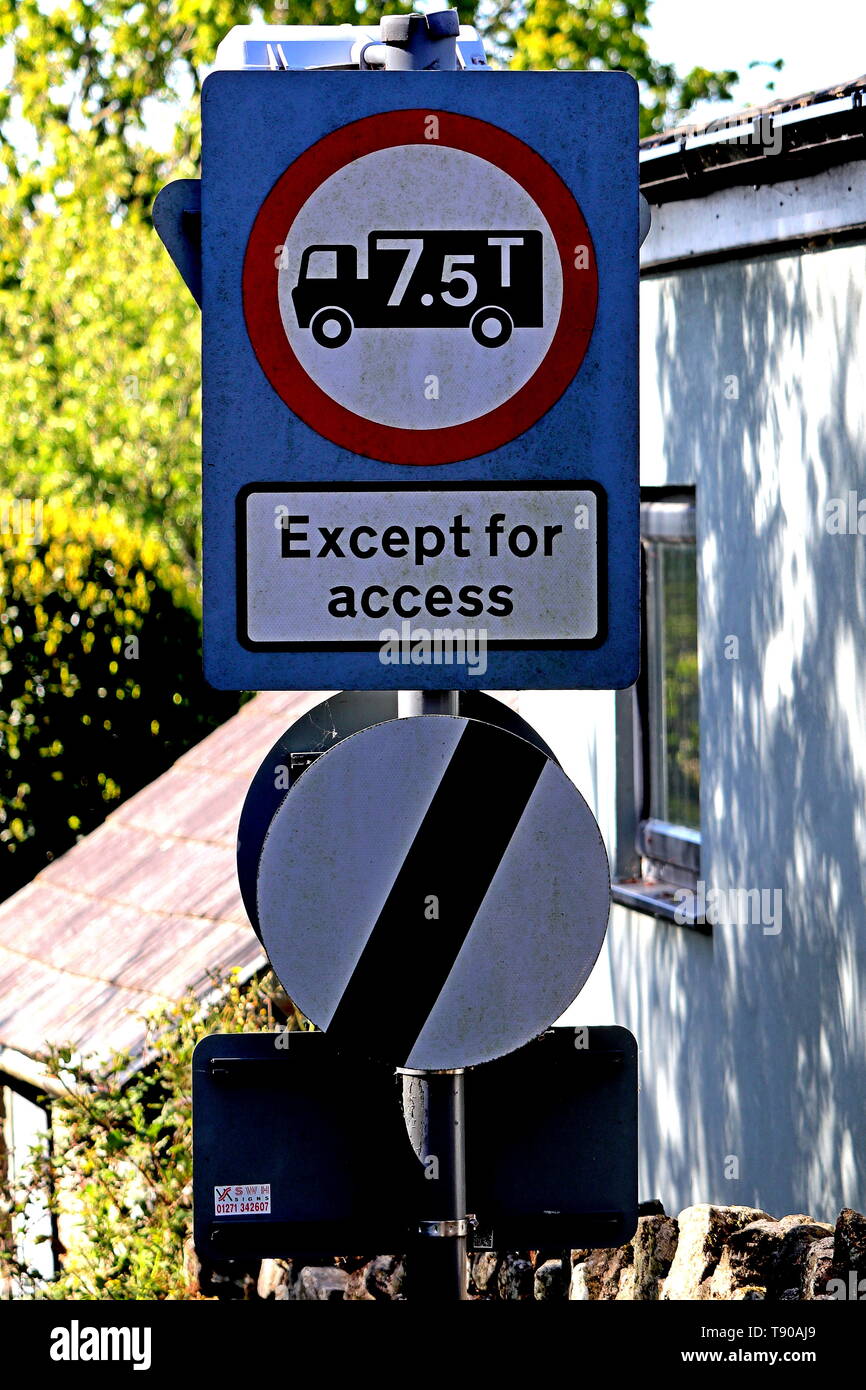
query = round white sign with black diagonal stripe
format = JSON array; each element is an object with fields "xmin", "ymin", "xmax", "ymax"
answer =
[{"xmin": 257, "ymin": 716, "xmax": 610, "ymax": 1070}]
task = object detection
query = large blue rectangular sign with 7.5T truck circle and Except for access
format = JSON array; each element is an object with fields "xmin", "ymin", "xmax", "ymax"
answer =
[{"xmin": 202, "ymin": 71, "xmax": 639, "ymax": 689}]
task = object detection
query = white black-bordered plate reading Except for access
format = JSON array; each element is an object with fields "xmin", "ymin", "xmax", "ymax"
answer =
[{"xmin": 238, "ymin": 482, "xmax": 605, "ymax": 651}]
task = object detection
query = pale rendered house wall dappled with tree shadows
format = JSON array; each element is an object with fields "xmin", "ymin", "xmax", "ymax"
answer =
[{"xmin": 610, "ymin": 246, "xmax": 866, "ymax": 1218}]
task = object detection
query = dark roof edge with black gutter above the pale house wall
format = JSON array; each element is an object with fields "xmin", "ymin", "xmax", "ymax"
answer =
[{"xmin": 639, "ymin": 75, "xmax": 866, "ymax": 203}]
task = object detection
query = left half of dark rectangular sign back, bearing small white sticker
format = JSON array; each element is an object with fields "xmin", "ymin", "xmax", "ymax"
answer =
[{"xmin": 192, "ymin": 1033, "xmax": 417, "ymax": 1259}]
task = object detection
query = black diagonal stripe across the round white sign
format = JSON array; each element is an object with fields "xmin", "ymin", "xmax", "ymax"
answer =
[{"xmin": 328, "ymin": 720, "xmax": 548, "ymax": 1062}]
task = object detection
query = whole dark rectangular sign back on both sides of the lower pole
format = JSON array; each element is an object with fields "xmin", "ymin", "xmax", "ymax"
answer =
[{"xmin": 192, "ymin": 1027, "xmax": 638, "ymax": 1261}]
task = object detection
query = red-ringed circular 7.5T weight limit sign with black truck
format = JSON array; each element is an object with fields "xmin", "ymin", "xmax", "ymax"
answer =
[{"xmin": 243, "ymin": 110, "xmax": 598, "ymax": 464}]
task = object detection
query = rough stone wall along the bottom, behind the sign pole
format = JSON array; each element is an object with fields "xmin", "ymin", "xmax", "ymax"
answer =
[{"xmin": 188, "ymin": 1202, "xmax": 866, "ymax": 1302}]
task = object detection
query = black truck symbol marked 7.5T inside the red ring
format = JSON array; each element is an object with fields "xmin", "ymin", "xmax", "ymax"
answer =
[{"xmin": 292, "ymin": 231, "xmax": 544, "ymax": 348}]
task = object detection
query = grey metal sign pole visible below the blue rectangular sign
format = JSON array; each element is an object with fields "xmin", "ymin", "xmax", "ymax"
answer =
[{"xmin": 398, "ymin": 691, "xmax": 467, "ymax": 1302}]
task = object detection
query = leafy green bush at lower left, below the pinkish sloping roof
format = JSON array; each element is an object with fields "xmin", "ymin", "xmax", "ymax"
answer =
[{"xmin": 0, "ymin": 972, "xmax": 304, "ymax": 1300}]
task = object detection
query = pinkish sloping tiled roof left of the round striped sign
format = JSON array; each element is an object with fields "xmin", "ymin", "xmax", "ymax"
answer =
[{"xmin": 0, "ymin": 692, "xmax": 327, "ymax": 1072}]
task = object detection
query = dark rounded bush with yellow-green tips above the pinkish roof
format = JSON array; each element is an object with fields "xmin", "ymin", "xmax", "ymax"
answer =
[{"xmin": 0, "ymin": 503, "xmax": 239, "ymax": 895}]
